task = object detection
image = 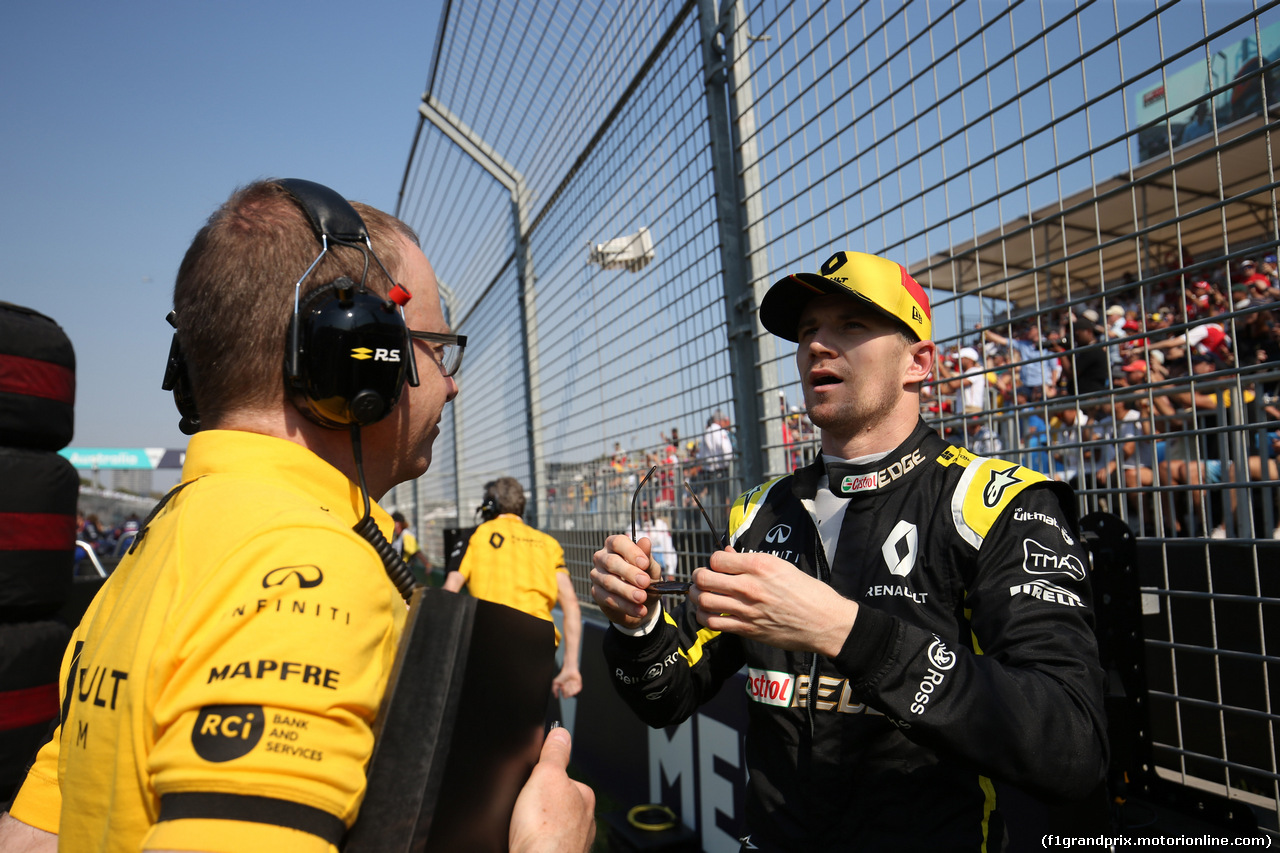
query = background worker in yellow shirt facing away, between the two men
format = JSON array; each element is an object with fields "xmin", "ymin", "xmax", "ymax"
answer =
[{"xmin": 444, "ymin": 476, "xmax": 582, "ymax": 698}]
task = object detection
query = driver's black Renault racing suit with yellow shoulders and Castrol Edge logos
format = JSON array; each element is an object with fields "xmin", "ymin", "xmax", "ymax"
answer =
[{"xmin": 604, "ymin": 421, "xmax": 1106, "ymax": 850}]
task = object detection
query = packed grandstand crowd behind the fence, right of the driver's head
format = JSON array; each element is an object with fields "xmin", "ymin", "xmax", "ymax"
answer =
[{"xmin": 929, "ymin": 249, "xmax": 1280, "ymax": 538}]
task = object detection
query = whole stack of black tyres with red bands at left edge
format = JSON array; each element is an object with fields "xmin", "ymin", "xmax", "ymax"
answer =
[{"xmin": 0, "ymin": 302, "xmax": 79, "ymax": 803}]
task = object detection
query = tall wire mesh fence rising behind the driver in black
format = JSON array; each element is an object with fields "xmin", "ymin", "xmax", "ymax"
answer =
[{"xmin": 389, "ymin": 0, "xmax": 1280, "ymax": 813}]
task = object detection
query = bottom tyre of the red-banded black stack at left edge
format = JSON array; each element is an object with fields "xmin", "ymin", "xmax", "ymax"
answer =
[{"xmin": 0, "ymin": 621, "xmax": 72, "ymax": 802}]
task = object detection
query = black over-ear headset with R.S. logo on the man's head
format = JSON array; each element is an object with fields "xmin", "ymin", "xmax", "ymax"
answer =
[{"xmin": 161, "ymin": 178, "xmax": 417, "ymax": 435}]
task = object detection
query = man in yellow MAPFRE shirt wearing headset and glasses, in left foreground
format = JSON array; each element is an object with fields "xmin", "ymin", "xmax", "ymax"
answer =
[{"xmin": 0, "ymin": 181, "xmax": 594, "ymax": 852}]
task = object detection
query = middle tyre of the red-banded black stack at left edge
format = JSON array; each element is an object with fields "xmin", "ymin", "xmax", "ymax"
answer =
[{"xmin": 0, "ymin": 447, "xmax": 79, "ymax": 622}]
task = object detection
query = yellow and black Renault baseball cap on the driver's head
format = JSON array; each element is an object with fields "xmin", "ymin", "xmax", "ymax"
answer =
[{"xmin": 760, "ymin": 251, "xmax": 933, "ymax": 341}]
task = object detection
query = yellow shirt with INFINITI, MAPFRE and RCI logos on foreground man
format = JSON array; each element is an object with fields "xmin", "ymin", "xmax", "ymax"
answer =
[{"xmin": 12, "ymin": 430, "xmax": 406, "ymax": 853}]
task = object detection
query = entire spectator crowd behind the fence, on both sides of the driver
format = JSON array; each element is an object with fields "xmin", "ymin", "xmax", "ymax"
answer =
[{"xmin": 547, "ymin": 254, "xmax": 1280, "ymax": 538}]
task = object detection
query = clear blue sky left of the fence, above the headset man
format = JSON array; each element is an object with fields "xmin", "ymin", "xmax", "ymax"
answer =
[{"xmin": 0, "ymin": 0, "xmax": 440, "ymax": 447}]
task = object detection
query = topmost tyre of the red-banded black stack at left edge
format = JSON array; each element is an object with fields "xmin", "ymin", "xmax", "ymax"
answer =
[{"xmin": 0, "ymin": 302, "xmax": 76, "ymax": 451}]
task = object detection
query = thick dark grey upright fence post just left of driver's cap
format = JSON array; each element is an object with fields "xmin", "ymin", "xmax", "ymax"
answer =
[{"xmin": 698, "ymin": 0, "xmax": 765, "ymax": 485}]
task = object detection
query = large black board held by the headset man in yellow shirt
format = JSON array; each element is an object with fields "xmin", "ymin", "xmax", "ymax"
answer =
[{"xmin": 342, "ymin": 588, "xmax": 556, "ymax": 853}]
